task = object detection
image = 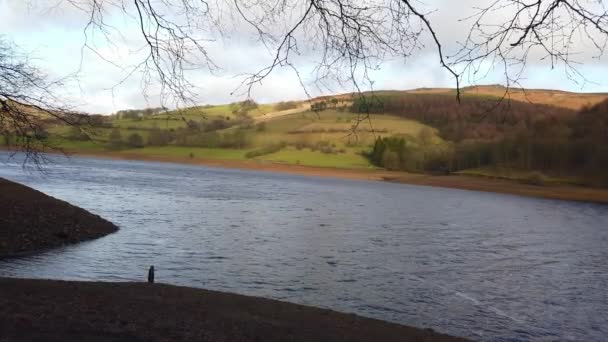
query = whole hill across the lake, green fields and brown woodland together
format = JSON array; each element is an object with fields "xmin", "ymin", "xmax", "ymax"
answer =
[{"xmin": 0, "ymin": 86, "xmax": 608, "ymax": 190}]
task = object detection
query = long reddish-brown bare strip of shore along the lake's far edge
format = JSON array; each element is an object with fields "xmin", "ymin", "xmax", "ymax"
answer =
[{"xmin": 50, "ymin": 151, "xmax": 608, "ymax": 203}]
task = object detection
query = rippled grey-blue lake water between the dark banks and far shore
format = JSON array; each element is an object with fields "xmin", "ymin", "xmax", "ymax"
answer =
[{"xmin": 0, "ymin": 153, "xmax": 608, "ymax": 341}]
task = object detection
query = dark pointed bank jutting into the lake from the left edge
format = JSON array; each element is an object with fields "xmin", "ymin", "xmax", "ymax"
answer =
[{"xmin": 0, "ymin": 178, "xmax": 118, "ymax": 258}]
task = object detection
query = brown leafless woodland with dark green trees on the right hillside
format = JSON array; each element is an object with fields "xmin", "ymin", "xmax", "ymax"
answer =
[{"xmin": 352, "ymin": 95, "xmax": 608, "ymax": 186}]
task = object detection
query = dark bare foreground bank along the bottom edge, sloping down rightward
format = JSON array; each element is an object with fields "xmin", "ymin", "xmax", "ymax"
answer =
[{"xmin": 0, "ymin": 278, "xmax": 463, "ymax": 342}]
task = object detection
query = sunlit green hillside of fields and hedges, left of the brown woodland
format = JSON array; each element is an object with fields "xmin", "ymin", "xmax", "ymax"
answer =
[{"xmin": 40, "ymin": 98, "xmax": 443, "ymax": 168}]
